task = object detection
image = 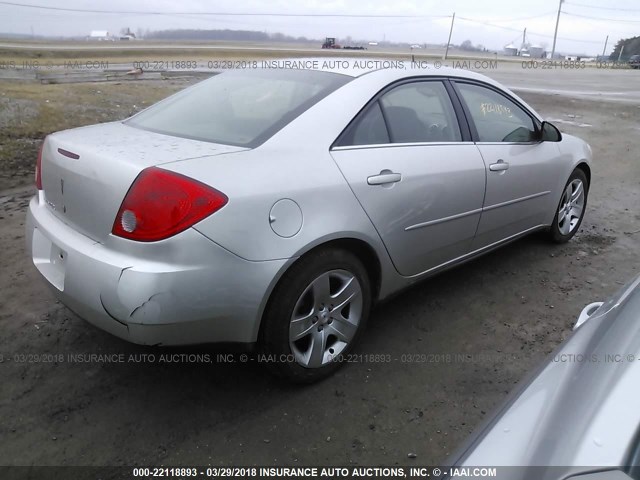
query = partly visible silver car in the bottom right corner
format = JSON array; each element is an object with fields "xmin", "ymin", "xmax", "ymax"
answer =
[{"xmin": 443, "ymin": 276, "xmax": 640, "ymax": 480}]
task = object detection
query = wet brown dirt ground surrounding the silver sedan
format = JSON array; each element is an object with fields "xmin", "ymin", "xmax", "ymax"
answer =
[{"xmin": 0, "ymin": 74, "xmax": 640, "ymax": 466}]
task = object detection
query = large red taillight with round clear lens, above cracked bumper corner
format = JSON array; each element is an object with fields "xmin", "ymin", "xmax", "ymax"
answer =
[{"xmin": 111, "ymin": 167, "xmax": 229, "ymax": 242}]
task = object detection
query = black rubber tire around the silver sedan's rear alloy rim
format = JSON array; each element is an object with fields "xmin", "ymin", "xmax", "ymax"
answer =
[{"xmin": 260, "ymin": 249, "xmax": 371, "ymax": 383}]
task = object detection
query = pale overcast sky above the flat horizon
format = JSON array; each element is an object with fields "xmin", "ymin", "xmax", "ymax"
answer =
[{"xmin": 0, "ymin": 0, "xmax": 640, "ymax": 54}]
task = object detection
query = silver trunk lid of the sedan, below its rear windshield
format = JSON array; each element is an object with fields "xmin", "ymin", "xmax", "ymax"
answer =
[{"xmin": 42, "ymin": 122, "xmax": 246, "ymax": 242}]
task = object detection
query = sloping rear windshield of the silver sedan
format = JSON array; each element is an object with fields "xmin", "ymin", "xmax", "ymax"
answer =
[{"xmin": 126, "ymin": 70, "xmax": 351, "ymax": 148}]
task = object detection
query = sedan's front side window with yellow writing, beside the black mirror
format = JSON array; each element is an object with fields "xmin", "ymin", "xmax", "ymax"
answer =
[{"xmin": 457, "ymin": 83, "xmax": 536, "ymax": 143}]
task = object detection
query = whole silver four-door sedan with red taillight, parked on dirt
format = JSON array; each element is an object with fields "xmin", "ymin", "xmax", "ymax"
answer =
[{"xmin": 26, "ymin": 61, "xmax": 591, "ymax": 381}]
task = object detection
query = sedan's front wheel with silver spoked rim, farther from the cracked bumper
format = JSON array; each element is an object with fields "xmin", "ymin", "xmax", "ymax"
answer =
[{"xmin": 549, "ymin": 169, "xmax": 589, "ymax": 243}]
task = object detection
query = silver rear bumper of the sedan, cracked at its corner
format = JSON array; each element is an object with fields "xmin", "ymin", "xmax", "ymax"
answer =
[{"xmin": 26, "ymin": 196, "xmax": 286, "ymax": 345}]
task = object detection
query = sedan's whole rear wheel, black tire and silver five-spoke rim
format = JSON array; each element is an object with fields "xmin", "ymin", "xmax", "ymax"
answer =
[{"xmin": 261, "ymin": 249, "xmax": 371, "ymax": 383}]
